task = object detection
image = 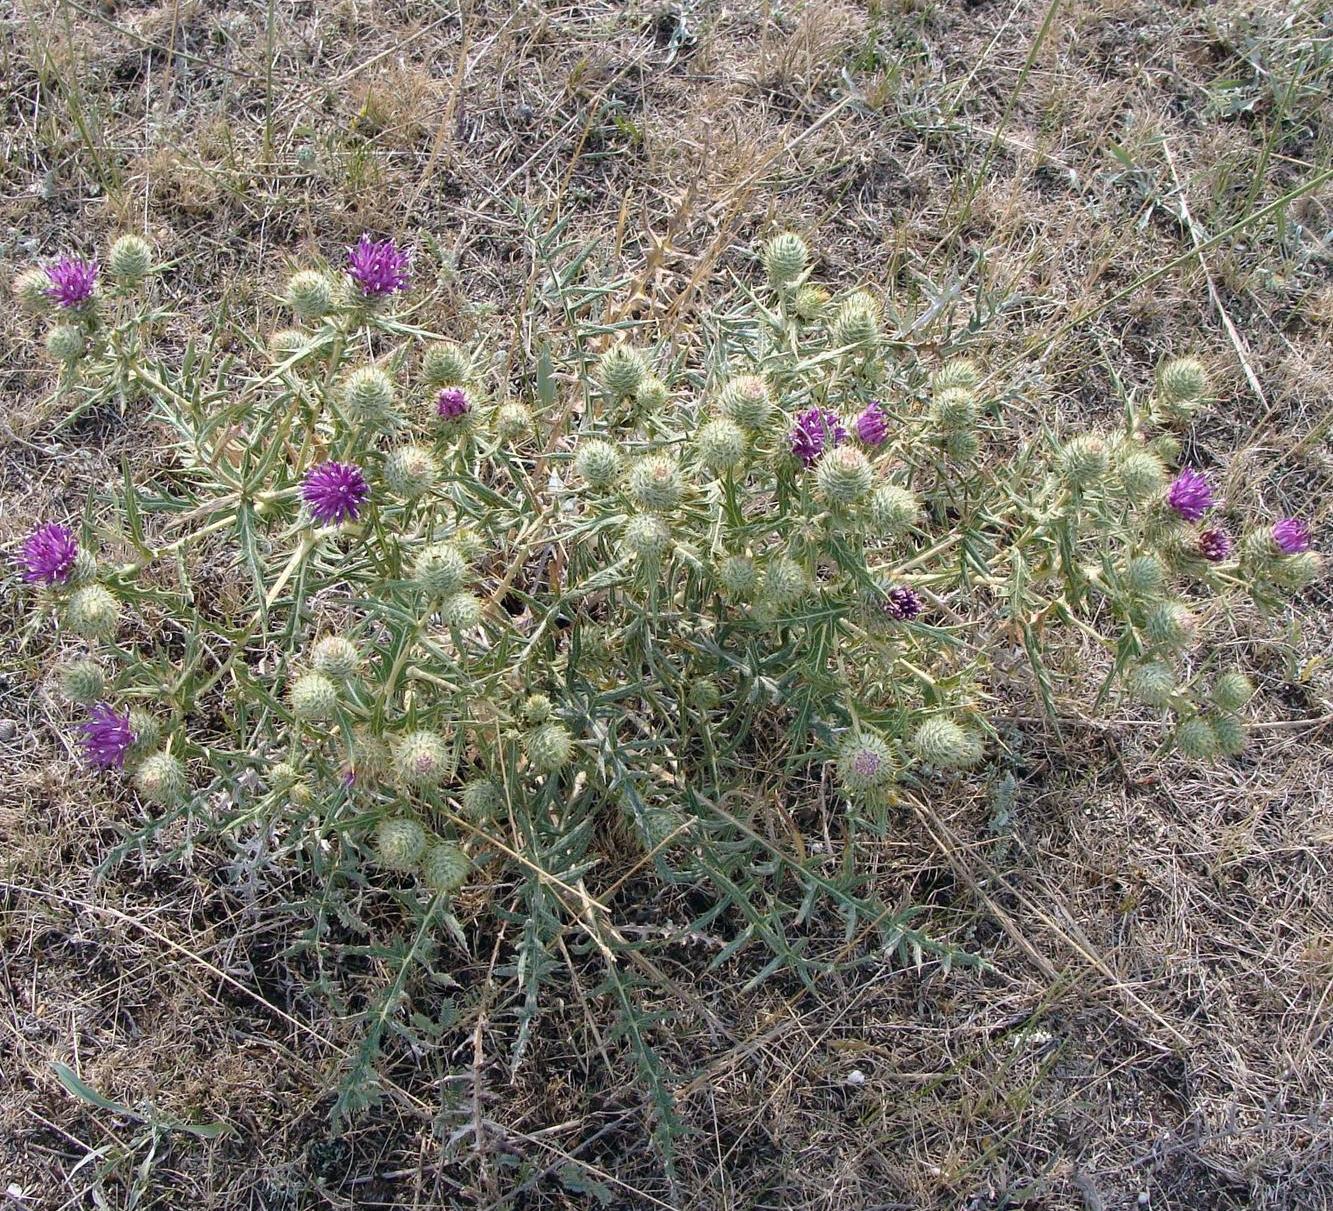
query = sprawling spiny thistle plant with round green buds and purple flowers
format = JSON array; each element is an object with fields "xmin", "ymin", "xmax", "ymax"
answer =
[{"xmin": 15, "ymin": 224, "xmax": 1320, "ymax": 1146}]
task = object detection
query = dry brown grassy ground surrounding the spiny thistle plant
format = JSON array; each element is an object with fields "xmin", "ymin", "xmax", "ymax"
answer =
[{"xmin": 0, "ymin": 0, "xmax": 1333, "ymax": 1211}]
